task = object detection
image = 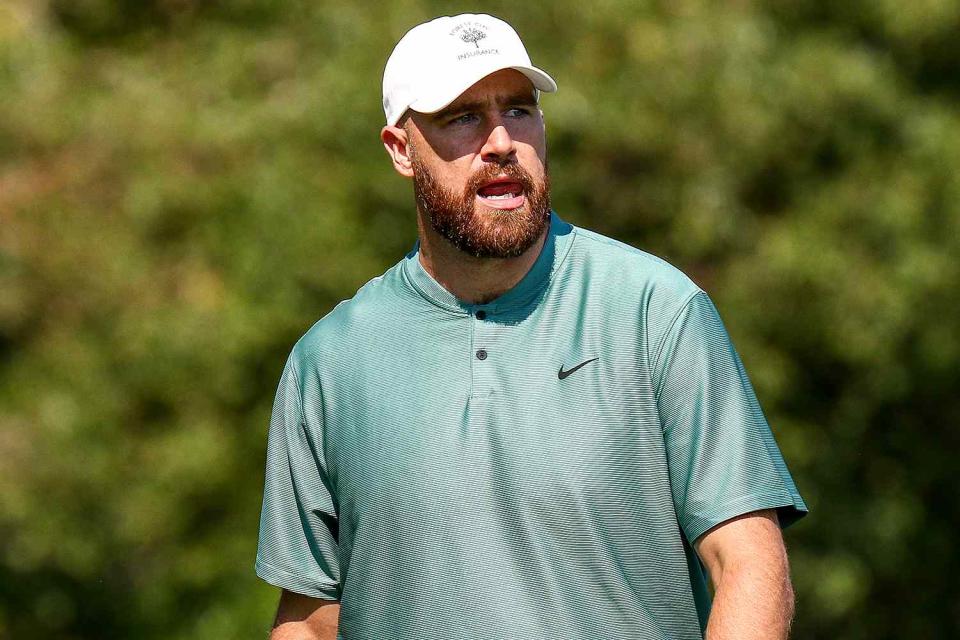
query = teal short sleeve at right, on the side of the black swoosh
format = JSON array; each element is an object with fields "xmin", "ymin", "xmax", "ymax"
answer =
[{"xmin": 654, "ymin": 291, "xmax": 807, "ymax": 544}]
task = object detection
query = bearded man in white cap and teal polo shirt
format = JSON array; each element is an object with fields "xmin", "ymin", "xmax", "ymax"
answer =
[{"xmin": 257, "ymin": 15, "xmax": 806, "ymax": 640}]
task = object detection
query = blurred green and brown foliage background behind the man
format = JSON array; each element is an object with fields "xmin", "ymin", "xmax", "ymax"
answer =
[{"xmin": 0, "ymin": 0, "xmax": 960, "ymax": 640}]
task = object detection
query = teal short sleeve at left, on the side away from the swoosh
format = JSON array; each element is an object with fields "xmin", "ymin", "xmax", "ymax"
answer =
[{"xmin": 256, "ymin": 356, "xmax": 340, "ymax": 600}]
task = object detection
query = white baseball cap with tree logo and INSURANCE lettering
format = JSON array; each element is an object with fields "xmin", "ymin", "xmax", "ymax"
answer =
[{"xmin": 383, "ymin": 13, "xmax": 557, "ymax": 125}]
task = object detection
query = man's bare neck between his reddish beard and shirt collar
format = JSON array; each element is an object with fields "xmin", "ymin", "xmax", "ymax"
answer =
[{"xmin": 417, "ymin": 215, "xmax": 550, "ymax": 304}]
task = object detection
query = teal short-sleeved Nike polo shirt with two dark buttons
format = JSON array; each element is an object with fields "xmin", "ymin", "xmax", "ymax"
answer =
[{"xmin": 256, "ymin": 214, "xmax": 806, "ymax": 640}]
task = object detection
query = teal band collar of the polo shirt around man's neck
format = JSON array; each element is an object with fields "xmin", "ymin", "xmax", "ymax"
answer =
[{"xmin": 403, "ymin": 211, "xmax": 573, "ymax": 314}]
